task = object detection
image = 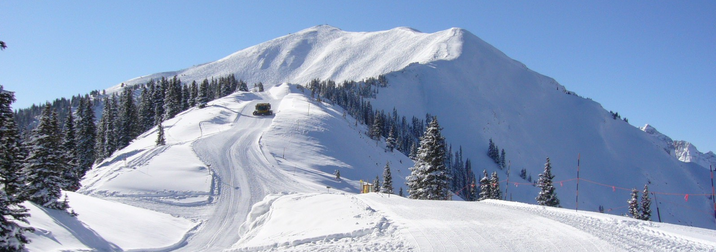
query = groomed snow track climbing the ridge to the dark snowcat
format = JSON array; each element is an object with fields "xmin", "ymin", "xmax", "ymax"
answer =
[{"xmin": 178, "ymin": 95, "xmax": 305, "ymax": 251}]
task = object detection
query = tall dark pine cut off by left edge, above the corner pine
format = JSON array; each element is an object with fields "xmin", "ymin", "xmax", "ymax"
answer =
[{"xmin": 0, "ymin": 85, "xmax": 24, "ymax": 204}]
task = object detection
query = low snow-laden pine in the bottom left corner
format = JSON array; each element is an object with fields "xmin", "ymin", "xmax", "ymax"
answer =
[{"xmin": 0, "ymin": 190, "xmax": 35, "ymax": 251}]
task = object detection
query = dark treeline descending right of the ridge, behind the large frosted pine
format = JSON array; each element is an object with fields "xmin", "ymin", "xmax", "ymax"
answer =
[{"xmin": 306, "ymin": 75, "xmax": 478, "ymax": 200}]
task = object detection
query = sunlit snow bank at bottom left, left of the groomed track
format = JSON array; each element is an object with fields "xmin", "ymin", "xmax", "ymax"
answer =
[{"xmin": 25, "ymin": 192, "xmax": 197, "ymax": 251}]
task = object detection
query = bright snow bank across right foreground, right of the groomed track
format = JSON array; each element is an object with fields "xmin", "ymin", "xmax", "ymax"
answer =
[{"xmin": 230, "ymin": 193, "xmax": 716, "ymax": 251}]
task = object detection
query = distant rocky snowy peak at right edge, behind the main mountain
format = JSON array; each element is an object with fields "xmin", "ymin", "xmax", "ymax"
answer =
[{"xmin": 640, "ymin": 124, "xmax": 716, "ymax": 169}]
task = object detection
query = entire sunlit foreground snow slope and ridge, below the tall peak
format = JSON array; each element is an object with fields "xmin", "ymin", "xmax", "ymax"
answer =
[{"xmin": 28, "ymin": 84, "xmax": 716, "ymax": 251}]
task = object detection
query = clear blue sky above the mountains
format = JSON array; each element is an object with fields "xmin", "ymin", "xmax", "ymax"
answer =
[{"xmin": 0, "ymin": 0, "xmax": 716, "ymax": 152}]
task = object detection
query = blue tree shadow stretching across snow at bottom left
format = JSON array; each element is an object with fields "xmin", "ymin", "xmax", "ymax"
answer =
[{"xmin": 38, "ymin": 206, "xmax": 122, "ymax": 251}]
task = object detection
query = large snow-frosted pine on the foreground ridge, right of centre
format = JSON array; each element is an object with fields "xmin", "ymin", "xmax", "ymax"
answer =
[{"xmin": 406, "ymin": 117, "xmax": 450, "ymax": 200}]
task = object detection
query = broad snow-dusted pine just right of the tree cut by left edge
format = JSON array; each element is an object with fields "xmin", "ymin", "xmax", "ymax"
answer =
[{"xmin": 23, "ymin": 103, "xmax": 67, "ymax": 209}]
